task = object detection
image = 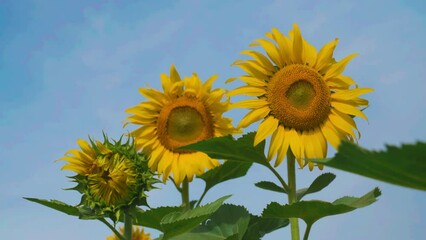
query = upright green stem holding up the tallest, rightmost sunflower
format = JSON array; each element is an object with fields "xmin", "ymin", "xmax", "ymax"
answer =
[{"xmin": 287, "ymin": 150, "xmax": 300, "ymax": 240}]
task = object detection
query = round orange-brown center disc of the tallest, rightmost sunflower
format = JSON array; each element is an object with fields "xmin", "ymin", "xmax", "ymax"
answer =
[{"xmin": 266, "ymin": 64, "xmax": 330, "ymax": 131}]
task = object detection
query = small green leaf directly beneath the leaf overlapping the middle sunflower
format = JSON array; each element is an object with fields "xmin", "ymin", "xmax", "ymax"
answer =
[{"xmin": 198, "ymin": 161, "xmax": 252, "ymax": 191}]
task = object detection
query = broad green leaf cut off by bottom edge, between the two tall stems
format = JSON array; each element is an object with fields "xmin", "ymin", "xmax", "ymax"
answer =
[{"xmin": 172, "ymin": 204, "xmax": 250, "ymax": 240}]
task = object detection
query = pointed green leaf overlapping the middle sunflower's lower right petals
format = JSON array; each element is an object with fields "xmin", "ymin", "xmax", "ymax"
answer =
[{"xmin": 179, "ymin": 132, "xmax": 269, "ymax": 166}]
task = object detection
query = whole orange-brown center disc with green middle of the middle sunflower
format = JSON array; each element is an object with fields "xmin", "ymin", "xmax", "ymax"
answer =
[{"xmin": 157, "ymin": 97, "xmax": 214, "ymax": 153}]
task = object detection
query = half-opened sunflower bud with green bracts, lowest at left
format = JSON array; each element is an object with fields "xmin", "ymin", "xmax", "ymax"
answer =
[{"xmin": 60, "ymin": 135, "xmax": 158, "ymax": 215}]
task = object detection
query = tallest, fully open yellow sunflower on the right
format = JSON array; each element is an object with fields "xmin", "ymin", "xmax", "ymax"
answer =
[{"xmin": 227, "ymin": 24, "xmax": 373, "ymax": 170}]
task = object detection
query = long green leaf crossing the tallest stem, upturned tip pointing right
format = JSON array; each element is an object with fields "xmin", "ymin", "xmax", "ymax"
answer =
[{"xmin": 262, "ymin": 188, "xmax": 381, "ymax": 225}]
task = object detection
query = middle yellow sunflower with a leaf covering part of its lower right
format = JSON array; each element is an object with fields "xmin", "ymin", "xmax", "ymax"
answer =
[{"xmin": 126, "ymin": 65, "xmax": 238, "ymax": 185}]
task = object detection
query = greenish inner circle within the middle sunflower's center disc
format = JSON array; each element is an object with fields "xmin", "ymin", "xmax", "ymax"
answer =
[{"xmin": 167, "ymin": 107, "xmax": 204, "ymax": 142}]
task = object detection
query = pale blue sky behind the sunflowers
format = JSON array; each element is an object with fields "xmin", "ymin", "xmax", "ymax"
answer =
[{"xmin": 0, "ymin": 0, "xmax": 426, "ymax": 240}]
